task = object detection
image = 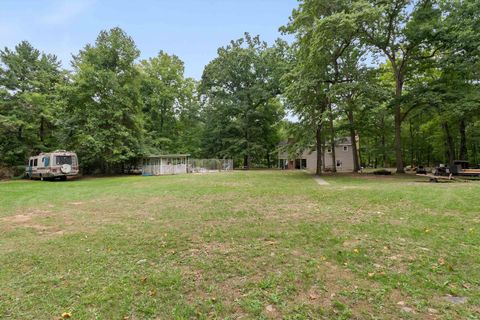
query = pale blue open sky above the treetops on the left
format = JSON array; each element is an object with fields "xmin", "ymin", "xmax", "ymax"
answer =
[{"xmin": 0, "ymin": 0, "xmax": 297, "ymax": 80}]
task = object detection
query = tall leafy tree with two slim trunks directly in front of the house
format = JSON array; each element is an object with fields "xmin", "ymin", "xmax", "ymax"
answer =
[{"xmin": 282, "ymin": 0, "xmax": 362, "ymax": 174}]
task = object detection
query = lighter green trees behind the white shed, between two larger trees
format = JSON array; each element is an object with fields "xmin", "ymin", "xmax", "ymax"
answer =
[{"xmin": 140, "ymin": 51, "xmax": 202, "ymax": 155}]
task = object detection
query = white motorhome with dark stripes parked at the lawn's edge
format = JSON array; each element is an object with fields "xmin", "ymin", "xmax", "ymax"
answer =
[{"xmin": 25, "ymin": 150, "xmax": 78, "ymax": 180}]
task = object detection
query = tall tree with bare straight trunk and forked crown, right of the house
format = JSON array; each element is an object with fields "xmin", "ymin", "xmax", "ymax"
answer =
[{"xmin": 353, "ymin": 0, "xmax": 441, "ymax": 173}]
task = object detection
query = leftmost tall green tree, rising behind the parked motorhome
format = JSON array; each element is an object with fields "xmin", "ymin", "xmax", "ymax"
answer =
[{"xmin": 0, "ymin": 41, "xmax": 64, "ymax": 165}]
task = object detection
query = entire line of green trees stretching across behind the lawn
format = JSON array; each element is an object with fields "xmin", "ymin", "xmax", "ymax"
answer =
[{"xmin": 0, "ymin": 0, "xmax": 480, "ymax": 174}]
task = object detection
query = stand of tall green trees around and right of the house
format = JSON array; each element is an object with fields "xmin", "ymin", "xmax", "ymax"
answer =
[{"xmin": 282, "ymin": 0, "xmax": 480, "ymax": 172}]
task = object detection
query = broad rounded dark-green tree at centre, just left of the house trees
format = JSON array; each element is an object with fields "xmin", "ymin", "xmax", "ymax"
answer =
[{"xmin": 201, "ymin": 34, "xmax": 286, "ymax": 168}]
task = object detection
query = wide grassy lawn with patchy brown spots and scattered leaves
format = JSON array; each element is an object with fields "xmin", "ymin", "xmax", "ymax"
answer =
[{"xmin": 0, "ymin": 171, "xmax": 480, "ymax": 320}]
